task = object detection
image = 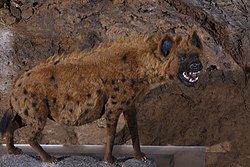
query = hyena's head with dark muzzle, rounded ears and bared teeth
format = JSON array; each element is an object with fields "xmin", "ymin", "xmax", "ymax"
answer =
[{"xmin": 158, "ymin": 32, "xmax": 203, "ymax": 86}]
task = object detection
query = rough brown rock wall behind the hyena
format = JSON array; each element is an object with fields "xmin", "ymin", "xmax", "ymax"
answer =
[{"xmin": 0, "ymin": 0, "xmax": 250, "ymax": 167}]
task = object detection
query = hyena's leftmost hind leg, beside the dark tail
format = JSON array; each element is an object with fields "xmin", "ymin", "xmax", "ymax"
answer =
[{"xmin": 6, "ymin": 114, "xmax": 25, "ymax": 154}]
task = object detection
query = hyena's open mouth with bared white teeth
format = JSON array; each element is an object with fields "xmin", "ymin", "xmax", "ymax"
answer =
[{"xmin": 179, "ymin": 71, "xmax": 200, "ymax": 86}]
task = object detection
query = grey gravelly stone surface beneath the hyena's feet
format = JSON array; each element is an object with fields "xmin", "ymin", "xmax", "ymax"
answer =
[{"xmin": 0, "ymin": 154, "xmax": 156, "ymax": 167}]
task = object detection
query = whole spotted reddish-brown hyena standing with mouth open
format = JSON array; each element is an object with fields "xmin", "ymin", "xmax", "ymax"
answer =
[{"xmin": 1, "ymin": 32, "xmax": 202, "ymax": 163}]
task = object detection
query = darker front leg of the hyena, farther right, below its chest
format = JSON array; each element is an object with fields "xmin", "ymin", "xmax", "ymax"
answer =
[{"xmin": 123, "ymin": 107, "xmax": 147, "ymax": 160}]
